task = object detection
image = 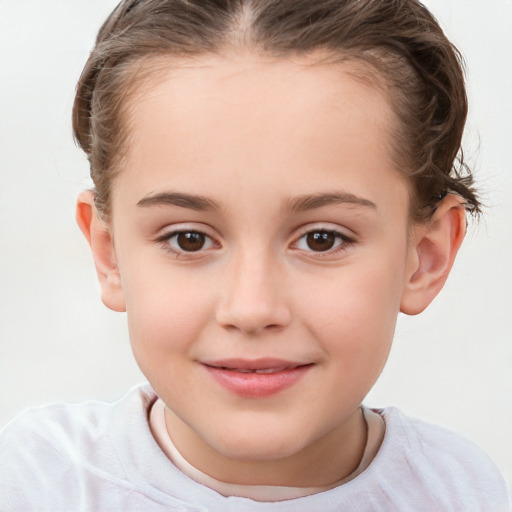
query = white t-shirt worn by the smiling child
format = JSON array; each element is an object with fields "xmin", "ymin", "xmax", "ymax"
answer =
[{"xmin": 0, "ymin": 385, "xmax": 512, "ymax": 512}]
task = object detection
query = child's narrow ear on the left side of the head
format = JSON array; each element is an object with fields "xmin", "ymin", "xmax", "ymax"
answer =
[{"xmin": 76, "ymin": 190, "xmax": 126, "ymax": 311}]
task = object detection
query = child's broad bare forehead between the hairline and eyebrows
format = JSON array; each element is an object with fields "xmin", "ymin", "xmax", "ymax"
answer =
[{"xmin": 114, "ymin": 54, "xmax": 408, "ymax": 211}]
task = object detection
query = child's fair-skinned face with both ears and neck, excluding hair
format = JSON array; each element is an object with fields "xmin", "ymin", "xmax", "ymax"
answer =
[{"xmin": 77, "ymin": 54, "xmax": 465, "ymax": 487}]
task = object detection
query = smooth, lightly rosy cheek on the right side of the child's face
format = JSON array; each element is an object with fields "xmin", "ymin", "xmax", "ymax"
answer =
[{"xmin": 301, "ymin": 251, "xmax": 403, "ymax": 362}]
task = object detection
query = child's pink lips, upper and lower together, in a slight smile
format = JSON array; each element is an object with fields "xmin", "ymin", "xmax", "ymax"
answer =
[{"xmin": 202, "ymin": 359, "xmax": 312, "ymax": 398}]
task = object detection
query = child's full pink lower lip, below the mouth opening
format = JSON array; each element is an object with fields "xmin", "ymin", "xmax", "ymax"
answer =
[{"xmin": 204, "ymin": 364, "xmax": 312, "ymax": 398}]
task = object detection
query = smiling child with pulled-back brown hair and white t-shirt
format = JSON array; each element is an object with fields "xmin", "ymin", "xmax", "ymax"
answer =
[{"xmin": 1, "ymin": 0, "xmax": 512, "ymax": 511}]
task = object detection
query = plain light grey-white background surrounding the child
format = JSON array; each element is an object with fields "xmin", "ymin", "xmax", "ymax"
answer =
[{"xmin": 0, "ymin": 0, "xmax": 512, "ymax": 482}]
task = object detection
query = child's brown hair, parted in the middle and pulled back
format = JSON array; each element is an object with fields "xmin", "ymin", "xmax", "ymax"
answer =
[{"xmin": 73, "ymin": 0, "xmax": 480, "ymax": 221}]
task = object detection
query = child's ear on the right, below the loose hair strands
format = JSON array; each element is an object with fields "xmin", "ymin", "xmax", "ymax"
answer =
[{"xmin": 400, "ymin": 194, "xmax": 466, "ymax": 315}]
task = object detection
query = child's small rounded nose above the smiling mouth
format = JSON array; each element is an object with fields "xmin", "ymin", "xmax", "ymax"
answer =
[{"xmin": 216, "ymin": 251, "xmax": 291, "ymax": 335}]
